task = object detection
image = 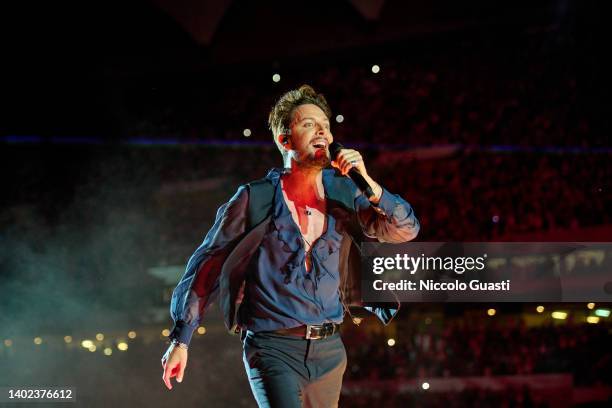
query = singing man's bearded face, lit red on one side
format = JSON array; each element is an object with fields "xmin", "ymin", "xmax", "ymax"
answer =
[{"xmin": 289, "ymin": 104, "xmax": 334, "ymax": 168}]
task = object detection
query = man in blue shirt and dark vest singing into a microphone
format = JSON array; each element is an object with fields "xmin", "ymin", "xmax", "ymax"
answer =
[{"xmin": 162, "ymin": 85, "xmax": 419, "ymax": 408}]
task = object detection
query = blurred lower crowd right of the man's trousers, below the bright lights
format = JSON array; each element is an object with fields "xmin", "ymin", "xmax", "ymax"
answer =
[{"xmin": 343, "ymin": 317, "xmax": 612, "ymax": 386}]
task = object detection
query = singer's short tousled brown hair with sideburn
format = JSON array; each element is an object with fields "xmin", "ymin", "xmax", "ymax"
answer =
[{"xmin": 268, "ymin": 85, "xmax": 331, "ymax": 153}]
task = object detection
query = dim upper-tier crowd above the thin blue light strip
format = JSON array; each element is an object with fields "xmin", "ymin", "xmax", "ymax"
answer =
[{"xmin": 125, "ymin": 28, "xmax": 610, "ymax": 147}]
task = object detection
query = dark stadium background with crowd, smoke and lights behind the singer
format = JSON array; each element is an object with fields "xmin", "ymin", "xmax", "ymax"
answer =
[{"xmin": 0, "ymin": 0, "xmax": 612, "ymax": 406}]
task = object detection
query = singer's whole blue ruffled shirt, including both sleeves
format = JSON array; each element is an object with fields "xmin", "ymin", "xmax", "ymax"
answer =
[{"xmin": 170, "ymin": 169, "xmax": 419, "ymax": 343}]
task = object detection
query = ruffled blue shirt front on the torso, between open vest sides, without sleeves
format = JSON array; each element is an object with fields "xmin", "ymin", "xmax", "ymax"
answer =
[{"xmin": 238, "ymin": 171, "xmax": 350, "ymax": 332}]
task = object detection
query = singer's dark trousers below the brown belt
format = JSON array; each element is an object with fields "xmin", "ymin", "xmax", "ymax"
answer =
[{"xmin": 243, "ymin": 331, "xmax": 346, "ymax": 408}]
